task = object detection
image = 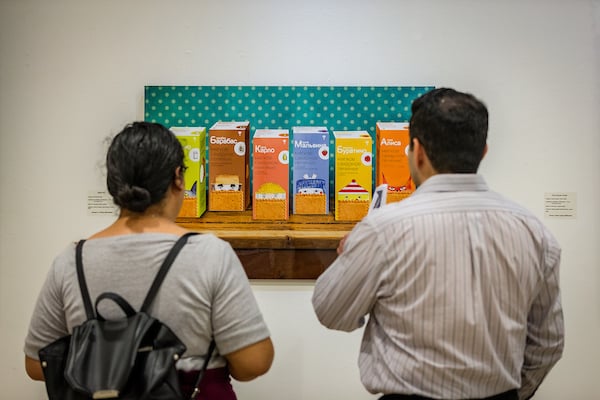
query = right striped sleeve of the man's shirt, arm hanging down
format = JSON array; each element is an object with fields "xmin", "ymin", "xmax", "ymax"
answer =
[{"xmin": 519, "ymin": 234, "xmax": 564, "ymax": 399}]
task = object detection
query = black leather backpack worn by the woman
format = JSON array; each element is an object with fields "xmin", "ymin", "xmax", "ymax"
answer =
[{"xmin": 38, "ymin": 232, "xmax": 215, "ymax": 400}]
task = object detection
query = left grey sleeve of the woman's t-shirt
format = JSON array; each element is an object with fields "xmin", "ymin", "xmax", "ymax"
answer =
[{"xmin": 24, "ymin": 252, "xmax": 69, "ymax": 360}]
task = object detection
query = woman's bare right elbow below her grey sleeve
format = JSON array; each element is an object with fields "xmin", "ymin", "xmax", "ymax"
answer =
[{"xmin": 224, "ymin": 338, "xmax": 275, "ymax": 381}]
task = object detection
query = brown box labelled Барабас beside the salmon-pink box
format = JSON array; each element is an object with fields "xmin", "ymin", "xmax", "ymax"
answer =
[{"xmin": 208, "ymin": 121, "xmax": 250, "ymax": 211}]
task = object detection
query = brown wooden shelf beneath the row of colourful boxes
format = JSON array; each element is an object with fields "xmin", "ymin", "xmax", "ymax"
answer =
[{"xmin": 177, "ymin": 211, "xmax": 356, "ymax": 279}]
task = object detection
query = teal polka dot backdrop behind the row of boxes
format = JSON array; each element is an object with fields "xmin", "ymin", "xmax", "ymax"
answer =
[{"xmin": 144, "ymin": 86, "xmax": 433, "ymax": 202}]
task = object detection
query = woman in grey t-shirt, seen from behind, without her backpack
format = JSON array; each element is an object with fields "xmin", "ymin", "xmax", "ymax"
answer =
[{"xmin": 25, "ymin": 122, "xmax": 273, "ymax": 399}]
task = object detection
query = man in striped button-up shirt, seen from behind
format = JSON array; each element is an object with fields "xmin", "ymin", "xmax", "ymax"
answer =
[{"xmin": 312, "ymin": 88, "xmax": 564, "ymax": 400}]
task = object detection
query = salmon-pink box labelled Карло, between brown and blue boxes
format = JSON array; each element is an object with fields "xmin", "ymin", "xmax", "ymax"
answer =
[{"xmin": 252, "ymin": 129, "xmax": 290, "ymax": 220}]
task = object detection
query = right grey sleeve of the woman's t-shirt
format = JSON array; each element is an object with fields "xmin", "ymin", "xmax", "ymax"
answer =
[{"xmin": 212, "ymin": 242, "xmax": 270, "ymax": 355}]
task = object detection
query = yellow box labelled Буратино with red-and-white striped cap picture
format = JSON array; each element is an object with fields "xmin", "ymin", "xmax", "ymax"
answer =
[{"xmin": 333, "ymin": 131, "xmax": 373, "ymax": 221}]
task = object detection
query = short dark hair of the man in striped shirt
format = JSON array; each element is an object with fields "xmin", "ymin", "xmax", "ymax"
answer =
[{"xmin": 409, "ymin": 88, "xmax": 488, "ymax": 173}]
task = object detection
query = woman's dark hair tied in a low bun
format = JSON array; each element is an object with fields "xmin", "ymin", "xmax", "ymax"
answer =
[{"xmin": 106, "ymin": 122, "xmax": 184, "ymax": 212}]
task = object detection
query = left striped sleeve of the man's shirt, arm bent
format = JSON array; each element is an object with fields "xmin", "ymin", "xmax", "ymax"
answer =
[{"xmin": 312, "ymin": 220, "xmax": 382, "ymax": 332}]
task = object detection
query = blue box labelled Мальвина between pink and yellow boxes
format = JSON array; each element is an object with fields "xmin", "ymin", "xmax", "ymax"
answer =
[{"xmin": 291, "ymin": 126, "xmax": 329, "ymax": 214}]
